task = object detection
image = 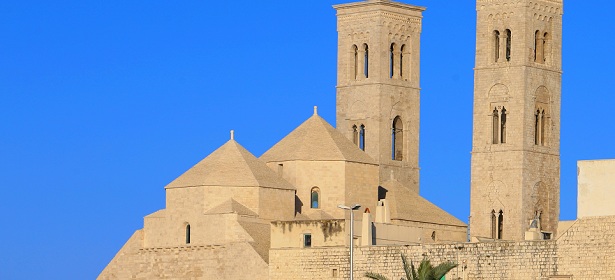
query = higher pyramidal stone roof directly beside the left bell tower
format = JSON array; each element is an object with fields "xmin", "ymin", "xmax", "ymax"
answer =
[{"xmin": 260, "ymin": 112, "xmax": 376, "ymax": 164}]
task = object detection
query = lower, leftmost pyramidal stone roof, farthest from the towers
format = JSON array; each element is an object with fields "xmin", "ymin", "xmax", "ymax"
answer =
[{"xmin": 165, "ymin": 136, "xmax": 295, "ymax": 190}]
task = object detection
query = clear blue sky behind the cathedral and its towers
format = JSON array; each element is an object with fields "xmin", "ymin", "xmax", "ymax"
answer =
[{"xmin": 0, "ymin": 0, "xmax": 615, "ymax": 279}]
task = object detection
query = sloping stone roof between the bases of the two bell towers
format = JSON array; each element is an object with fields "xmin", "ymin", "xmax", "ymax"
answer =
[{"xmin": 382, "ymin": 180, "xmax": 466, "ymax": 226}]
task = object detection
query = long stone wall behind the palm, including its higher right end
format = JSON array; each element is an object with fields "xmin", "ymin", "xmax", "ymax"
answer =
[{"xmin": 269, "ymin": 216, "xmax": 615, "ymax": 280}]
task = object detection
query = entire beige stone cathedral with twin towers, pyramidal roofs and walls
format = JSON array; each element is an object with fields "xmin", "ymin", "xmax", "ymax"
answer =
[{"xmin": 98, "ymin": 0, "xmax": 615, "ymax": 279}]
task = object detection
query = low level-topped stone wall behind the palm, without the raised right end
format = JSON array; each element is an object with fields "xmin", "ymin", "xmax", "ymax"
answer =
[{"xmin": 269, "ymin": 241, "xmax": 557, "ymax": 280}]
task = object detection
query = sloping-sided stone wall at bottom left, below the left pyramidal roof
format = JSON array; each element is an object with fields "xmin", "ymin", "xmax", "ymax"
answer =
[{"xmin": 97, "ymin": 230, "xmax": 268, "ymax": 280}]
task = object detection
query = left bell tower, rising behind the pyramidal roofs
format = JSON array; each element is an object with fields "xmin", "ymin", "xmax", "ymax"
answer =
[{"xmin": 334, "ymin": 0, "xmax": 425, "ymax": 192}]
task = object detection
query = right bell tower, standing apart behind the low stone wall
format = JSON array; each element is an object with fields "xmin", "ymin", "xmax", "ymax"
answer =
[{"xmin": 470, "ymin": 0, "xmax": 563, "ymax": 240}]
